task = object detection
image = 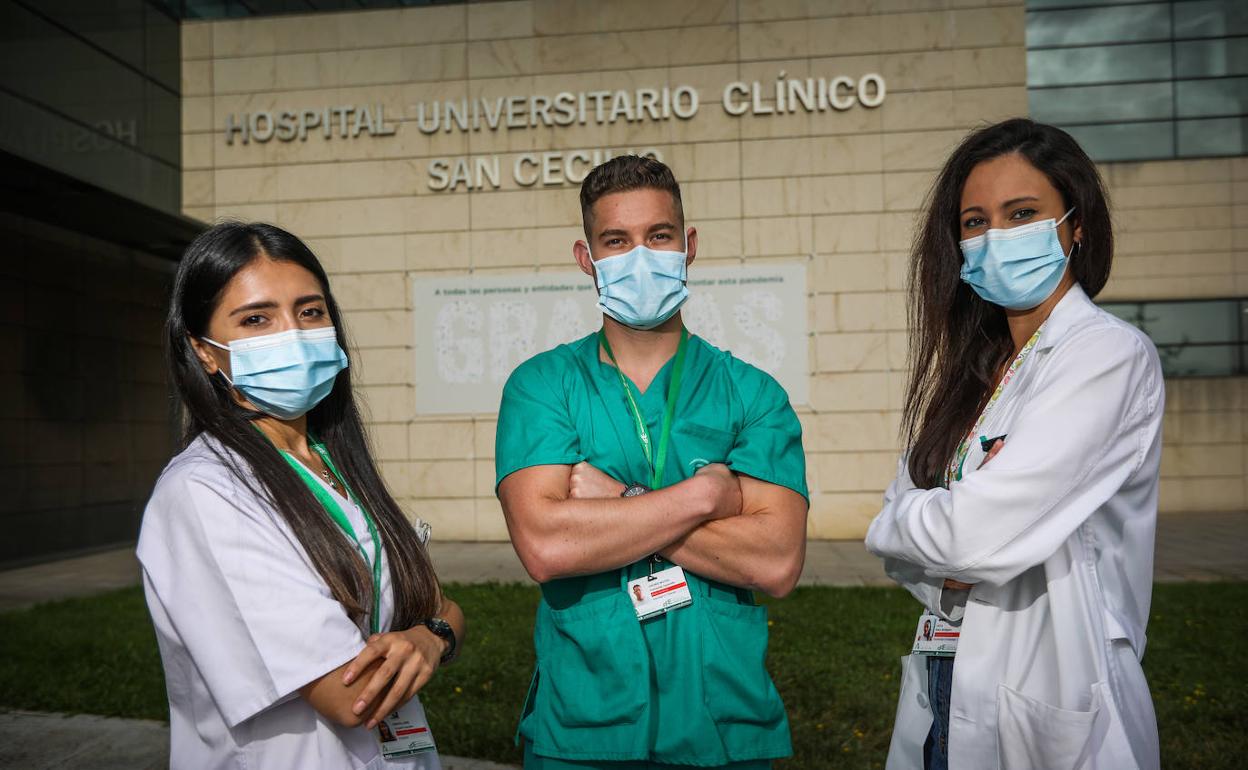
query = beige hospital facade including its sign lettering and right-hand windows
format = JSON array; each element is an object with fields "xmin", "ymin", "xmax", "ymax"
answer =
[{"xmin": 181, "ymin": 0, "xmax": 1248, "ymax": 540}]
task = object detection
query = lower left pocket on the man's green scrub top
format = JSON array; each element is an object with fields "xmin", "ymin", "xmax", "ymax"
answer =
[{"xmin": 538, "ymin": 593, "xmax": 650, "ymax": 728}]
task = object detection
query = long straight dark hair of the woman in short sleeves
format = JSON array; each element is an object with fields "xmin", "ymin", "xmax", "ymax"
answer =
[{"xmin": 165, "ymin": 222, "xmax": 441, "ymax": 629}]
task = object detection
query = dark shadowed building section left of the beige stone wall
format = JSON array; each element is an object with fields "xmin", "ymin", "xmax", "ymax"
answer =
[{"xmin": 0, "ymin": 0, "xmax": 202, "ymax": 568}]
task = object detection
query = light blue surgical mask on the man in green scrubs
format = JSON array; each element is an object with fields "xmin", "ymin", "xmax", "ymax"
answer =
[{"xmin": 594, "ymin": 246, "xmax": 689, "ymax": 329}]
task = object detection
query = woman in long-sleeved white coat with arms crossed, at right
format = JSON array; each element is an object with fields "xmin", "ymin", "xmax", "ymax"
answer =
[{"xmin": 866, "ymin": 119, "xmax": 1164, "ymax": 770}]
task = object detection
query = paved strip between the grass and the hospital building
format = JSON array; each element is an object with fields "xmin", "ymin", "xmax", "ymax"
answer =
[{"xmin": 0, "ymin": 513, "xmax": 1248, "ymax": 612}]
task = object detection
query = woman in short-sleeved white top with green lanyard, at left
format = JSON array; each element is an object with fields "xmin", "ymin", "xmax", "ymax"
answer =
[{"xmin": 139, "ymin": 222, "xmax": 464, "ymax": 770}]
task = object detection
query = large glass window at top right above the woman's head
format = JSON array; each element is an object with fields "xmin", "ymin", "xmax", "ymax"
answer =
[{"xmin": 1026, "ymin": 0, "xmax": 1248, "ymax": 161}]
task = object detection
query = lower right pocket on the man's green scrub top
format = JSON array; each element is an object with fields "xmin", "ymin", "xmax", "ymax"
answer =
[{"xmin": 694, "ymin": 597, "xmax": 785, "ymax": 726}]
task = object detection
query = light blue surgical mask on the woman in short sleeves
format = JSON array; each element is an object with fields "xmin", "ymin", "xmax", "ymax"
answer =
[{"xmin": 203, "ymin": 326, "xmax": 347, "ymax": 419}]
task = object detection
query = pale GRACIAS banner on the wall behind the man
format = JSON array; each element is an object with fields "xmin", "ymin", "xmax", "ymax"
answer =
[{"xmin": 412, "ymin": 262, "xmax": 810, "ymax": 414}]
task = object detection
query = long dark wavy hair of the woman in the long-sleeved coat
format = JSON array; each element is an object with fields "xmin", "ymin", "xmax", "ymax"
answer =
[{"xmin": 901, "ymin": 119, "xmax": 1113, "ymax": 488}]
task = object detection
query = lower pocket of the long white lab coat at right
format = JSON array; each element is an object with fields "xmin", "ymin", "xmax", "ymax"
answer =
[{"xmin": 997, "ymin": 683, "xmax": 1109, "ymax": 770}]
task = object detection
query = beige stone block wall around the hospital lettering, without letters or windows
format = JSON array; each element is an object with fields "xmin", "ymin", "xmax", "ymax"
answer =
[{"xmin": 182, "ymin": 0, "xmax": 1248, "ymax": 539}]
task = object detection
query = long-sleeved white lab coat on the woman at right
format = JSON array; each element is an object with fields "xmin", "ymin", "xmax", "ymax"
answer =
[{"xmin": 866, "ymin": 286, "xmax": 1164, "ymax": 770}]
